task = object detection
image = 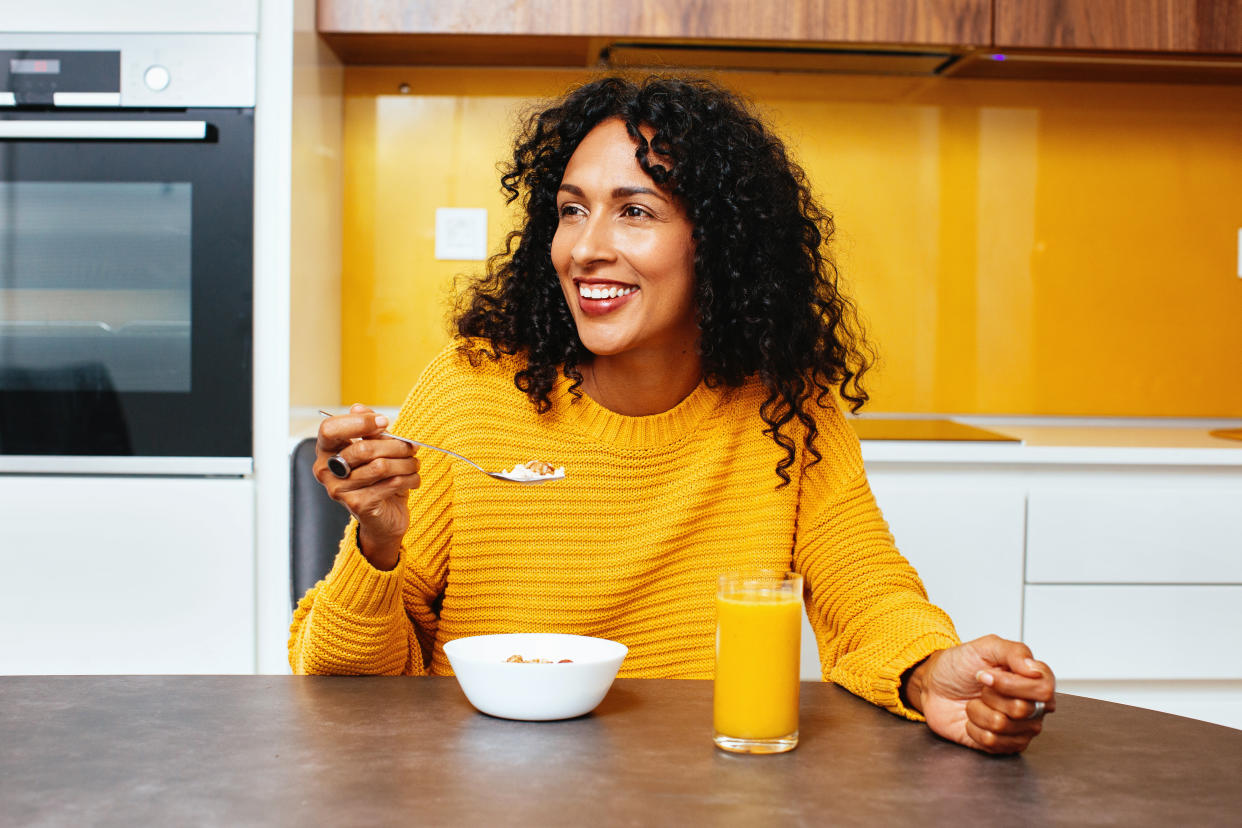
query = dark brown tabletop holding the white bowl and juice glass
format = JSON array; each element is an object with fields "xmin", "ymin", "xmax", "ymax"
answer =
[{"xmin": 0, "ymin": 675, "xmax": 1242, "ymax": 826}]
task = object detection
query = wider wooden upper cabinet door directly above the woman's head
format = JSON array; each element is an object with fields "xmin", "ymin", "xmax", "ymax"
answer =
[{"xmin": 318, "ymin": 0, "xmax": 992, "ymax": 46}]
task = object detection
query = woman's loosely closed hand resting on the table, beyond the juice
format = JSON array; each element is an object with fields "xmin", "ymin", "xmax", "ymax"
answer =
[{"xmin": 907, "ymin": 636, "xmax": 1057, "ymax": 754}]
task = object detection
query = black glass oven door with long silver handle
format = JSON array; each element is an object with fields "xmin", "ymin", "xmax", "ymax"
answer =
[{"xmin": 0, "ymin": 109, "xmax": 253, "ymax": 473}]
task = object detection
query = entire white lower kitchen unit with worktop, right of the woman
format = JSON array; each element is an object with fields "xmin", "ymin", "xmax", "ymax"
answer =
[{"xmin": 863, "ymin": 434, "xmax": 1242, "ymax": 727}]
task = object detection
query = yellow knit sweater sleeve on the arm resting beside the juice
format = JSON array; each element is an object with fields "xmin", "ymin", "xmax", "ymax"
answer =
[{"xmin": 794, "ymin": 408, "xmax": 960, "ymax": 720}]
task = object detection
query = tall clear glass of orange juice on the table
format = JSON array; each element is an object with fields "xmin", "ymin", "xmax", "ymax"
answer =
[{"xmin": 713, "ymin": 571, "xmax": 802, "ymax": 754}]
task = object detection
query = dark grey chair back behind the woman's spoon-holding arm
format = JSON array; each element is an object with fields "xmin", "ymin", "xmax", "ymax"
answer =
[{"xmin": 289, "ymin": 437, "xmax": 349, "ymax": 607}]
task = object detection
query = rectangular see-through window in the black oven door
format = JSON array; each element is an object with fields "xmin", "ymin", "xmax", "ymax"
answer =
[{"xmin": 0, "ymin": 181, "xmax": 193, "ymax": 392}]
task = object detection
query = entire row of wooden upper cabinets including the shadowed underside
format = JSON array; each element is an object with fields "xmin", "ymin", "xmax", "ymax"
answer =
[{"xmin": 317, "ymin": 0, "xmax": 1242, "ymax": 76}]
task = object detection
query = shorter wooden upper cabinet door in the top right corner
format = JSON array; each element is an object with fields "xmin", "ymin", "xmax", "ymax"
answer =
[{"xmin": 994, "ymin": 0, "xmax": 1242, "ymax": 55}]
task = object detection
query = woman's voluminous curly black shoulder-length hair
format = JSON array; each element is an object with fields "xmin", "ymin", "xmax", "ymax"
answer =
[{"xmin": 456, "ymin": 76, "xmax": 873, "ymax": 485}]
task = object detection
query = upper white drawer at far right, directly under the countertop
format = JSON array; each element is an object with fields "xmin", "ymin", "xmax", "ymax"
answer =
[{"xmin": 1026, "ymin": 488, "xmax": 1242, "ymax": 583}]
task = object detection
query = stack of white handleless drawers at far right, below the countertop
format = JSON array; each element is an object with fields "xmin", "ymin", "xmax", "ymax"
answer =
[{"xmin": 1023, "ymin": 466, "xmax": 1242, "ymax": 727}]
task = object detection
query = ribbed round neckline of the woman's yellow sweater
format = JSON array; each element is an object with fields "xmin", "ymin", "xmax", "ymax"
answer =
[{"xmin": 556, "ymin": 375, "xmax": 727, "ymax": 448}]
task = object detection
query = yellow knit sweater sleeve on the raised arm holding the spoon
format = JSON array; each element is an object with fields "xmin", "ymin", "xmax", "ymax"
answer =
[{"xmin": 289, "ymin": 346, "xmax": 461, "ymax": 675}]
